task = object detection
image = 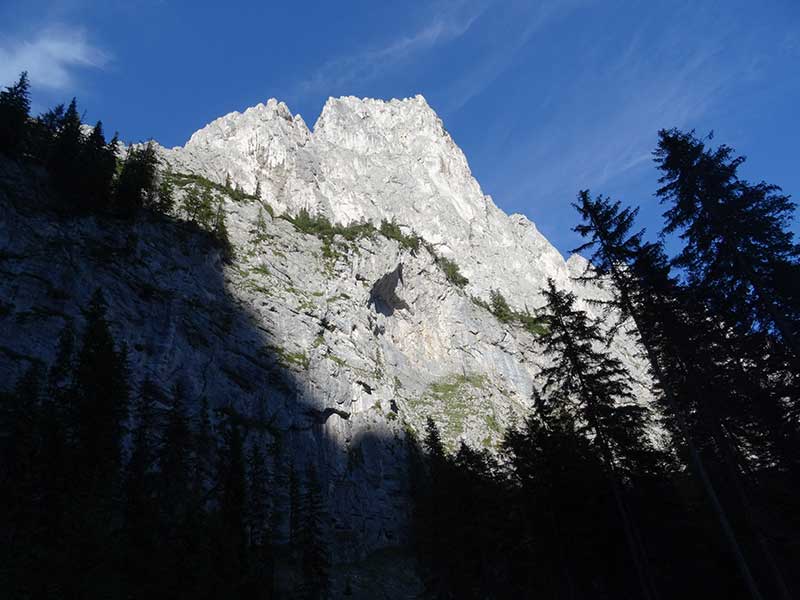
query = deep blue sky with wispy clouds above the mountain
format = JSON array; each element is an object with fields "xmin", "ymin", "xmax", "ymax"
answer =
[{"xmin": 0, "ymin": 0, "xmax": 800, "ymax": 252}]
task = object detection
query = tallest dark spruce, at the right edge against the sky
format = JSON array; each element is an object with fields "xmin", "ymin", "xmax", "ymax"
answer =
[{"xmin": 654, "ymin": 129, "xmax": 800, "ymax": 510}]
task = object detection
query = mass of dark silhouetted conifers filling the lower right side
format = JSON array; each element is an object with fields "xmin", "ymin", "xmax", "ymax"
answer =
[{"xmin": 412, "ymin": 130, "xmax": 800, "ymax": 599}]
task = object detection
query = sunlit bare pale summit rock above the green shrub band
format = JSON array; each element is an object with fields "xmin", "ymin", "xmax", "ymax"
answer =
[{"xmin": 163, "ymin": 95, "xmax": 569, "ymax": 308}]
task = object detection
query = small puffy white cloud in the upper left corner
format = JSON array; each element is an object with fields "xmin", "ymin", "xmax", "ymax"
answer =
[{"xmin": 0, "ymin": 25, "xmax": 111, "ymax": 90}]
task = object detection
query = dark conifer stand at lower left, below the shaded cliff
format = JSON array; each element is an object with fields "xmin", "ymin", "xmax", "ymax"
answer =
[{"xmin": 0, "ymin": 292, "xmax": 328, "ymax": 598}]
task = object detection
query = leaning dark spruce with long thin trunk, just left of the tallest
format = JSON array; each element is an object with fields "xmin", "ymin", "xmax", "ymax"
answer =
[{"xmin": 574, "ymin": 191, "xmax": 792, "ymax": 597}]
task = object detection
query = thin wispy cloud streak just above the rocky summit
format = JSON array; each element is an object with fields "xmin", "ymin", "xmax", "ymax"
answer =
[{"xmin": 299, "ymin": 2, "xmax": 486, "ymax": 93}]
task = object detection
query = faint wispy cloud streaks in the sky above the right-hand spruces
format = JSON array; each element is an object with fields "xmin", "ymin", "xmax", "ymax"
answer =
[{"xmin": 488, "ymin": 12, "xmax": 743, "ymax": 209}]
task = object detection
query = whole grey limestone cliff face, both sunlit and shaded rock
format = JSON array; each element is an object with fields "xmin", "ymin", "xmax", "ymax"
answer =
[{"xmin": 0, "ymin": 96, "xmax": 647, "ymax": 572}]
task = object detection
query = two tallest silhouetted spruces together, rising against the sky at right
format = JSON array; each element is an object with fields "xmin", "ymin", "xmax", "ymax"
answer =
[{"xmin": 575, "ymin": 130, "xmax": 799, "ymax": 598}]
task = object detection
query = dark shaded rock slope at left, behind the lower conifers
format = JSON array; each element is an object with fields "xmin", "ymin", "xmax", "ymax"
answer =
[{"xmin": 0, "ymin": 159, "xmax": 424, "ymax": 597}]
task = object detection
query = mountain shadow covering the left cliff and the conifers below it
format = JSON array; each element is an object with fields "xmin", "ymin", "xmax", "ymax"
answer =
[{"xmin": 0, "ymin": 158, "xmax": 421, "ymax": 598}]
